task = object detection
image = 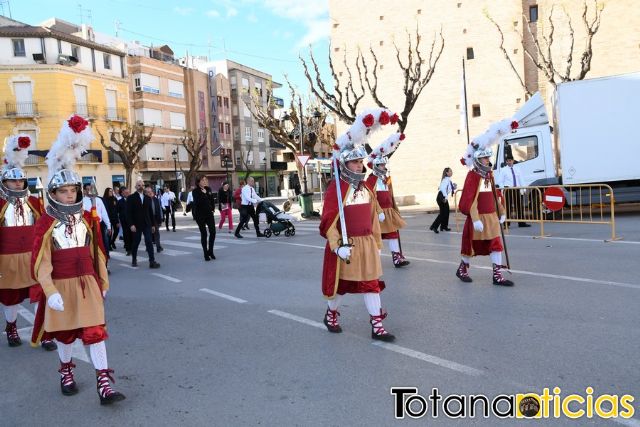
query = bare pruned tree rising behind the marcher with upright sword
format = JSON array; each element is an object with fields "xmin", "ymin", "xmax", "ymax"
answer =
[{"xmin": 300, "ymin": 26, "xmax": 445, "ymax": 131}]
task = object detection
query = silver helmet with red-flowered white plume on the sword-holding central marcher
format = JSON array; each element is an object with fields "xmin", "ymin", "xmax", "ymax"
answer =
[{"xmin": 333, "ymin": 108, "xmax": 398, "ymax": 187}]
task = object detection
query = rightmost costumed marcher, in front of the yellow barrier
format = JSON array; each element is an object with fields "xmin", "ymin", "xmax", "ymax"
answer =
[{"xmin": 456, "ymin": 120, "xmax": 518, "ymax": 286}]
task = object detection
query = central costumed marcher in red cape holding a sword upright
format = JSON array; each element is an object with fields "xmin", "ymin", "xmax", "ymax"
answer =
[{"xmin": 320, "ymin": 109, "xmax": 397, "ymax": 341}]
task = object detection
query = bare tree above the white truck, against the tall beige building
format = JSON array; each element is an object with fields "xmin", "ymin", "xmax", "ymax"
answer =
[{"xmin": 485, "ymin": 0, "xmax": 604, "ymax": 94}]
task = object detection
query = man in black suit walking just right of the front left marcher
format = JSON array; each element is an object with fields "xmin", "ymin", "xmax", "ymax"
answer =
[{"xmin": 127, "ymin": 179, "xmax": 160, "ymax": 268}]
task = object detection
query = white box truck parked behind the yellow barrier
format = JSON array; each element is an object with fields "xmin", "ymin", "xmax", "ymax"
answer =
[{"xmin": 494, "ymin": 73, "xmax": 640, "ymax": 202}]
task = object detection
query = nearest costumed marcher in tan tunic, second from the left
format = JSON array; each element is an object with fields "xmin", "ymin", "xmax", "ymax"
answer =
[{"xmin": 31, "ymin": 116, "xmax": 124, "ymax": 404}]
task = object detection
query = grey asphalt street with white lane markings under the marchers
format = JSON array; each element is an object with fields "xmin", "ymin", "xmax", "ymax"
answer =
[{"xmin": 0, "ymin": 212, "xmax": 640, "ymax": 426}]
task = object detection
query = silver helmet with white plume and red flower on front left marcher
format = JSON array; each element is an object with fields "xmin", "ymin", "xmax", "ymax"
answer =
[{"xmin": 47, "ymin": 115, "xmax": 94, "ymax": 214}]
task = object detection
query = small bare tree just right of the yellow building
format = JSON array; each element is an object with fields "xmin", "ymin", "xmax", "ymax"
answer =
[{"xmin": 98, "ymin": 123, "xmax": 154, "ymax": 189}]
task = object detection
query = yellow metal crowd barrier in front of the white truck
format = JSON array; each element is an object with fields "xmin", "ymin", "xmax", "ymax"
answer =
[{"xmin": 453, "ymin": 184, "xmax": 620, "ymax": 241}]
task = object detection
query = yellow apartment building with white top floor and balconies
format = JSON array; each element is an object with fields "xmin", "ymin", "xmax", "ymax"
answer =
[{"xmin": 0, "ymin": 16, "xmax": 129, "ymax": 190}]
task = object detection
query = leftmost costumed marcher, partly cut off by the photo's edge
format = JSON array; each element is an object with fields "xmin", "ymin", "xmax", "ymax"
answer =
[{"xmin": 0, "ymin": 135, "xmax": 56, "ymax": 351}]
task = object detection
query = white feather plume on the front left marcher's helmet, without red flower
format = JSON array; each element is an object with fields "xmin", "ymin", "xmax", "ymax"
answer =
[{"xmin": 47, "ymin": 116, "xmax": 94, "ymax": 181}]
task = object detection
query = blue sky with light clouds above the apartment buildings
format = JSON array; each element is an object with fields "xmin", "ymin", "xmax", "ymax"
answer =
[{"xmin": 4, "ymin": 0, "xmax": 329, "ymax": 103}]
